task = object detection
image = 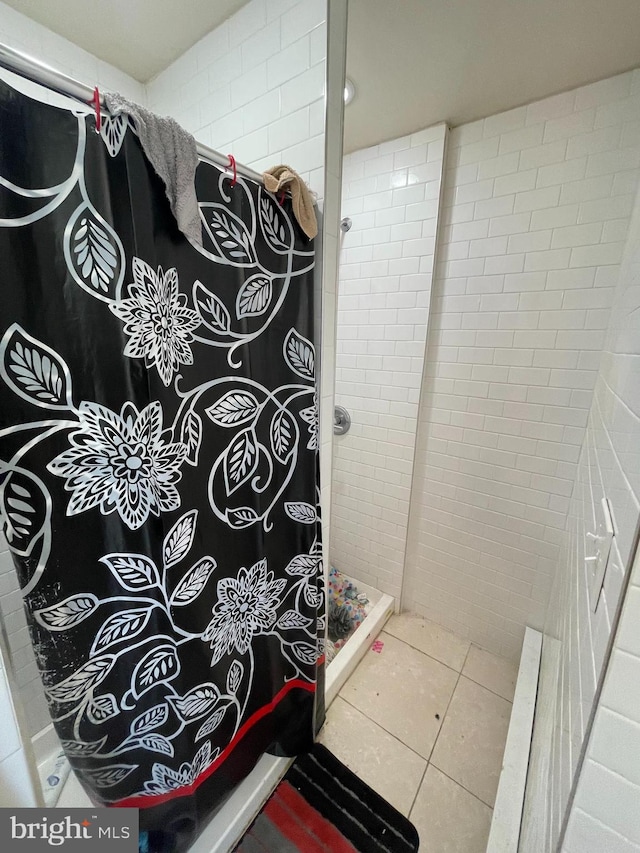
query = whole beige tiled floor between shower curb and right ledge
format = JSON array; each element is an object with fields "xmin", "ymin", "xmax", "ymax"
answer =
[{"xmin": 320, "ymin": 614, "xmax": 517, "ymax": 853}]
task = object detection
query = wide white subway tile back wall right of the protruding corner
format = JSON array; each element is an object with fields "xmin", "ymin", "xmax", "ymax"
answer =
[{"xmin": 404, "ymin": 72, "xmax": 640, "ymax": 659}]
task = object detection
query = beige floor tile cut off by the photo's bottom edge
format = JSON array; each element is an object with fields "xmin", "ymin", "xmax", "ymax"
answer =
[{"xmin": 410, "ymin": 764, "xmax": 492, "ymax": 853}]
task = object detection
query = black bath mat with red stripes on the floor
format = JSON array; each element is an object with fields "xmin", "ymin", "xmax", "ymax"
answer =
[{"xmin": 234, "ymin": 744, "xmax": 419, "ymax": 853}]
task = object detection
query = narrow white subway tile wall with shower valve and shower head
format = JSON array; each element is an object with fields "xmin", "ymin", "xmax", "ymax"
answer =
[{"xmin": 330, "ymin": 125, "xmax": 447, "ymax": 599}]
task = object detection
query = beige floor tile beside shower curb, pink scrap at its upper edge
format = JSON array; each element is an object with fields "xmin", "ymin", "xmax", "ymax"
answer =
[{"xmin": 340, "ymin": 632, "xmax": 458, "ymax": 758}]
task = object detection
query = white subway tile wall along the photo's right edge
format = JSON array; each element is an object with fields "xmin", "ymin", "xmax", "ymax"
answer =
[{"xmin": 564, "ymin": 176, "xmax": 640, "ymax": 853}]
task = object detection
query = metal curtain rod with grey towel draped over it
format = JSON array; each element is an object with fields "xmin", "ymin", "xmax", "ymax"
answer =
[{"xmin": 0, "ymin": 42, "xmax": 264, "ymax": 184}]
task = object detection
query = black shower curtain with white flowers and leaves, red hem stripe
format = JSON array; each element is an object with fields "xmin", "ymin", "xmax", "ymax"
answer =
[{"xmin": 0, "ymin": 76, "xmax": 324, "ymax": 851}]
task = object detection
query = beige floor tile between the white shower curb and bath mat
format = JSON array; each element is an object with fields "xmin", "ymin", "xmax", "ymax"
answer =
[{"xmin": 319, "ymin": 697, "xmax": 427, "ymax": 816}]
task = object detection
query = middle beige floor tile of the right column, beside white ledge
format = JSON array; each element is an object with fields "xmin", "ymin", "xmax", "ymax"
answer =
[{"xmin": 431, "ymin": 676, "xmax": 511, "ymax": 807}]
